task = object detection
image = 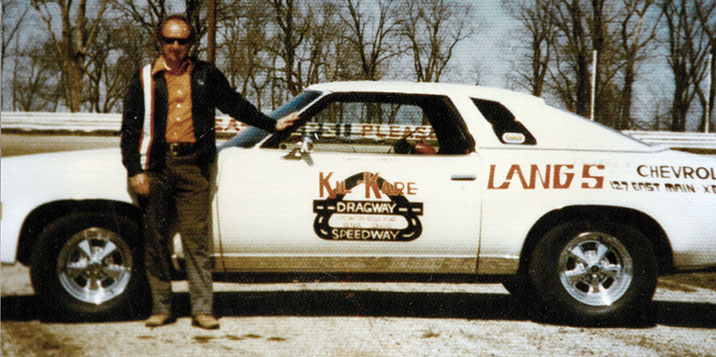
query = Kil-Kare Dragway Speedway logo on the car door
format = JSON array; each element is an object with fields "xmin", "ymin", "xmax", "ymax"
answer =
[{"xmin": 313, "ymin": 172, "xmax": 423, "ymax": 242}]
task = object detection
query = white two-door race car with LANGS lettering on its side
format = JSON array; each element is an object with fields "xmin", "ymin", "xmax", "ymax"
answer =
[{"xmin": 1, "ymin": 82, "xmax": 716, "ymax": 324}]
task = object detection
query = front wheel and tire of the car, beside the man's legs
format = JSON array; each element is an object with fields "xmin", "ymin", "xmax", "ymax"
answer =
[{"xmin": 30, "ymin": 213, "xmax": 150, "ymax": 320}]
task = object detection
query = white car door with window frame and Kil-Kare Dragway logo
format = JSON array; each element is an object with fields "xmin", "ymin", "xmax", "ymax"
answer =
[{"xmin": 216, "ymin": 93, "xmax": 484, "ymax": 272}]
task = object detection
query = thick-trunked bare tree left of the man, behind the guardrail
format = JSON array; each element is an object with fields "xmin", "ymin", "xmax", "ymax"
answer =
[{"xmin": 31, "ymin": 0, "xmax": 108, "ymax": 112}]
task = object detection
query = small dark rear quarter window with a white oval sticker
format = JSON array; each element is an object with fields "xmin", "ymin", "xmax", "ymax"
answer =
[{"xmin": 472, "ymin": 98, "xmax": 537, "ymax": 145}]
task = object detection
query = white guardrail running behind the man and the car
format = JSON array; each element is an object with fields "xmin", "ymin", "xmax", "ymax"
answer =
[{"xmin": 0, "ymin": 112, "xmax": 716, "ymax": 150}]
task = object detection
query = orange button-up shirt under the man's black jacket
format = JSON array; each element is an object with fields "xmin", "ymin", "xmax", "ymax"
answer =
[{"xmin": 152, "ymin": 57, "xmax": 196, "ymax": 143}]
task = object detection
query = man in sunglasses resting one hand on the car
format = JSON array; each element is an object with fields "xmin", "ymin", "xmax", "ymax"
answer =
[{"xmin": 120, "ymin": 15, "xmax": 298, "ymax": 329}]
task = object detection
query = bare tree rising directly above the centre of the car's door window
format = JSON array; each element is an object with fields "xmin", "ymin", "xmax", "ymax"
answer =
[{"xmin": 341, "ymin": 0, "xmax": 403, "ymax": 80}]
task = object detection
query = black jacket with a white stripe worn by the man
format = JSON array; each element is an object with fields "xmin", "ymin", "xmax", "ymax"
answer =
[{"xmin": 120, "ymin": 59, "xmax": 276, "ymax": 177}]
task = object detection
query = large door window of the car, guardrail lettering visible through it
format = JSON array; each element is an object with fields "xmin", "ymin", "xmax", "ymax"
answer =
[{"xmin": 269, "ymin": 93, "xmax": 474, "ymax": 155}]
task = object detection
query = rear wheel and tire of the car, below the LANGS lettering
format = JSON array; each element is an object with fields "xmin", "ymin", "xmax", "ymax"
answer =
[{"xmin": 529, "ymin": 221, "xmax": 657, "ymax": 326}]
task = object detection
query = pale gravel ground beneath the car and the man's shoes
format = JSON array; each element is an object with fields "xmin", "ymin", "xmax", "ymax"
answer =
[{"xmin": 0, "ymin": 265, "xmax": 716, "ymax": 356}]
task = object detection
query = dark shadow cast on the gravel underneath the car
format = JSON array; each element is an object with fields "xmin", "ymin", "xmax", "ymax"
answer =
[{"xmin": 0, "ymin": 290, "xmax": 716, "ymax": 329}]
